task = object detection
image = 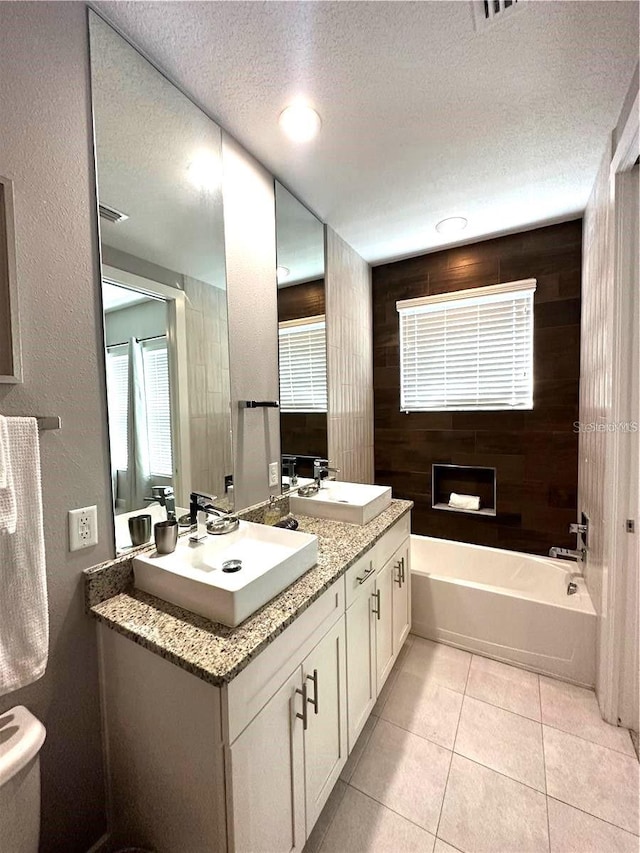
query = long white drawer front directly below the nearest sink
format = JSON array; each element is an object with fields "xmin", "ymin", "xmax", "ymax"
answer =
[{"xmin": 224, "ymin": 578, "xmax": 344, "ymax": 743}]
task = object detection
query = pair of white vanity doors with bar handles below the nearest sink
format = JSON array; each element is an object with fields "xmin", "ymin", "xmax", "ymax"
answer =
[{"xmin": 227, "ymin": 617, "xmax": 347, "ymax": 853}]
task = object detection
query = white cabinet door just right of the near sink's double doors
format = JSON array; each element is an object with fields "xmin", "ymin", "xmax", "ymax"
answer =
[{"xmin": 346, "ymin": 575, "xmax": 376, "ymax": 752}]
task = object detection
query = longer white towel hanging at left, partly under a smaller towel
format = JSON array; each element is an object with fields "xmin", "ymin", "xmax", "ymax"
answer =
[{"xmin": 0, "ymin": 418, "xmax": 49, "ymax": 696}]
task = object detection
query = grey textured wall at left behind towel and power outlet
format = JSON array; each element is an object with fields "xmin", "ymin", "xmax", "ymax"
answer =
[{"xmin": 0, "ymin": 2, "xmax": 113, "ymax": 853}]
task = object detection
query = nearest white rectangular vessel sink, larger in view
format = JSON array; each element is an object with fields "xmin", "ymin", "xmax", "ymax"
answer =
[{"xmin": 133, "ymin": 521, "xmax": 318, "ymax": 627}]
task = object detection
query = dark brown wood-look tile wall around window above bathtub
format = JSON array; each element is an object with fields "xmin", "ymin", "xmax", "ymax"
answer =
[{"xmin": 373, "ymin": 220, "xmax": 582, "ymax": 554}]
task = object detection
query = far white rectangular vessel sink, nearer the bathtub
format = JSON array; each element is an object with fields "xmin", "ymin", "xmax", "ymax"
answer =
[{"xmin": 289, "ymin": 480, "xmax": 391, "ymax": 524}]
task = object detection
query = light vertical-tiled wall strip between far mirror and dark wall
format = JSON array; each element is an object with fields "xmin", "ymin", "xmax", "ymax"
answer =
[{"xmin": 325, "ymin": 226, "xmax": 374, "ymax": 483}]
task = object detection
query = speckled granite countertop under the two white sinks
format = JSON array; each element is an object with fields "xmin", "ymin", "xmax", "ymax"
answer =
[{"xmin": 85, "ymin": 500, "xmax": 413, "ymax": 686}]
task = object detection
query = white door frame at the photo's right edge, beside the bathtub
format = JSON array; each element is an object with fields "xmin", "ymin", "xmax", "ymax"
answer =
[{"xmin": 599, "ymin": 94, "xmax": 640, "ymax": 731}]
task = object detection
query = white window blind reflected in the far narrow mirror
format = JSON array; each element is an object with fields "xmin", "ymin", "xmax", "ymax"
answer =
[{"xmin": 278, "ymin": 315, "xmax": 327, "ymax": 412}]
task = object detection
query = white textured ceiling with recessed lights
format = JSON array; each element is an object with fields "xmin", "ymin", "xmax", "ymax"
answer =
[{"xmin": 96, "ymin": 0, "xmax": 638, "ymax": 263}]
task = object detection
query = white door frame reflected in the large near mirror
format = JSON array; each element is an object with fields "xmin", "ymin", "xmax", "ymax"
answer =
[{"xmin": 101, "ymin": 264, "xmax": 191, "ymax": 506}]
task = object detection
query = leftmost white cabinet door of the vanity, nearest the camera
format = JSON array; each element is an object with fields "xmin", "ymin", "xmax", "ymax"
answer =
[{"xmin": 230, "ymin": 668, "xmax": 305, "ymax": 853}]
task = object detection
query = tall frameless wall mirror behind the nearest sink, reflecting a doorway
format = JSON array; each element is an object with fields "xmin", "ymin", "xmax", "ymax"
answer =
[{"xmin": 89, "ymin": 12, "xmax": 233, "ymax": 551}]
